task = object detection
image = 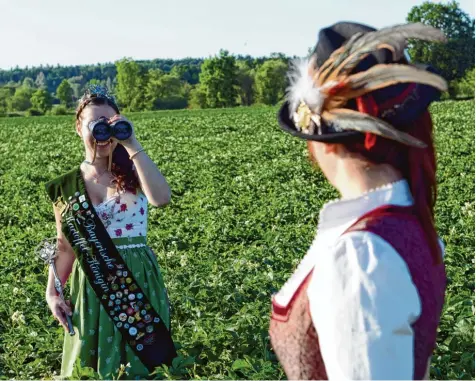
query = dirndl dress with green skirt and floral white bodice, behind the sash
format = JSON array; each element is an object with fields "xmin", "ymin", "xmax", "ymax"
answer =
[{"xmin": 61, "ymin": 191, "xmax": 170, "ymax": 379}]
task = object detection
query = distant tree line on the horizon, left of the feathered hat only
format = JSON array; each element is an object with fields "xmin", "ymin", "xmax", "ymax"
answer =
[{"xmin": 0, "ymin": 50, "xmax": 291, "ymax": 115}]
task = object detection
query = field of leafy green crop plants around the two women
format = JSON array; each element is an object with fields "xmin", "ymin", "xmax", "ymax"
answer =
[{"xmin": 0, "ymin": 101, "xmax": 475, "ymax": 379}]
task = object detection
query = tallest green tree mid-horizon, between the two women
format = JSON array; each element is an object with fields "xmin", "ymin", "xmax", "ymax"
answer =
[{"xmin": 200, "ymin": 50, "xmax": 238, "ymax": 107}]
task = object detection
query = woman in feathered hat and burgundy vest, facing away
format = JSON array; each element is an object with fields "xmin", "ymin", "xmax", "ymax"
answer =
[{"xmin": 270, "ymin": 22, "xmax": 446, "ymax": 380}]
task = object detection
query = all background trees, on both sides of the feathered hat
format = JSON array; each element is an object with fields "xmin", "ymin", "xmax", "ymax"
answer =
[{"xmin": 0, "ymin": 1, "xmax": 475, "ymax": 115}]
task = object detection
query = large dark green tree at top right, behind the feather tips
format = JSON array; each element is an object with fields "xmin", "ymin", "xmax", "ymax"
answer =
[{"xmin": 407, "ymin": 1, "xmax": 475, "ymax": 81}]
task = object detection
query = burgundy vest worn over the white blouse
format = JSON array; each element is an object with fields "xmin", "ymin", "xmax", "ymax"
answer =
[{"xmin": 269, "ymin": 206, "xmax": 446, "ymax": 380}]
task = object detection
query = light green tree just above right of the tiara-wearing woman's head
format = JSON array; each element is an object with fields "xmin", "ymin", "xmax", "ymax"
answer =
[{"xmin": 116, "ymin": 58, "xmax": 146, "ymax": 111}]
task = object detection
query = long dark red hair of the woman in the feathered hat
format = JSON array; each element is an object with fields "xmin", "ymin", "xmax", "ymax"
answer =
[{"xmin": 310, "ymin": 97, "xmax": 442, "ymax": 263}]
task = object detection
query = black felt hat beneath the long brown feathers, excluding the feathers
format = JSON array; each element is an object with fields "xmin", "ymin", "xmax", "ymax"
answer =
[{"xmin": 278, "ymin": 22, "xmax": 444, "ymax": 142}]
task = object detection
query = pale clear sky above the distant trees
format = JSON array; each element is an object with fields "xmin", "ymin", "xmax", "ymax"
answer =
[{"xmin": 0, "ymin": 0, "xmax": 474, "ymax": 69}]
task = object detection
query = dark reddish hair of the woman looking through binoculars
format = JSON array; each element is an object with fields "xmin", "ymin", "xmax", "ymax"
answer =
[{"xmin": 76, "ymin": 96, "xmax": 139, "ymax": 192}]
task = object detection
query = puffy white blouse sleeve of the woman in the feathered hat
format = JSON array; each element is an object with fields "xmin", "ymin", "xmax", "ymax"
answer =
[{"xmin": 307, "ymin": 232, "xmax": 421, "ymax": 380}]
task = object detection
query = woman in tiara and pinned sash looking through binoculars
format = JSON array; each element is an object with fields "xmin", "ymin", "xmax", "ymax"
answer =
[{"xmin": 46, "ymin": 86, "xmax": 175, "ymax": 378}]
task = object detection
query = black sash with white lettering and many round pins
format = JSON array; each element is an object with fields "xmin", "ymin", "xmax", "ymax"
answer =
[{"xmin": 46, "ymin": 168, "xmax": 177, "ymax": 372}]
